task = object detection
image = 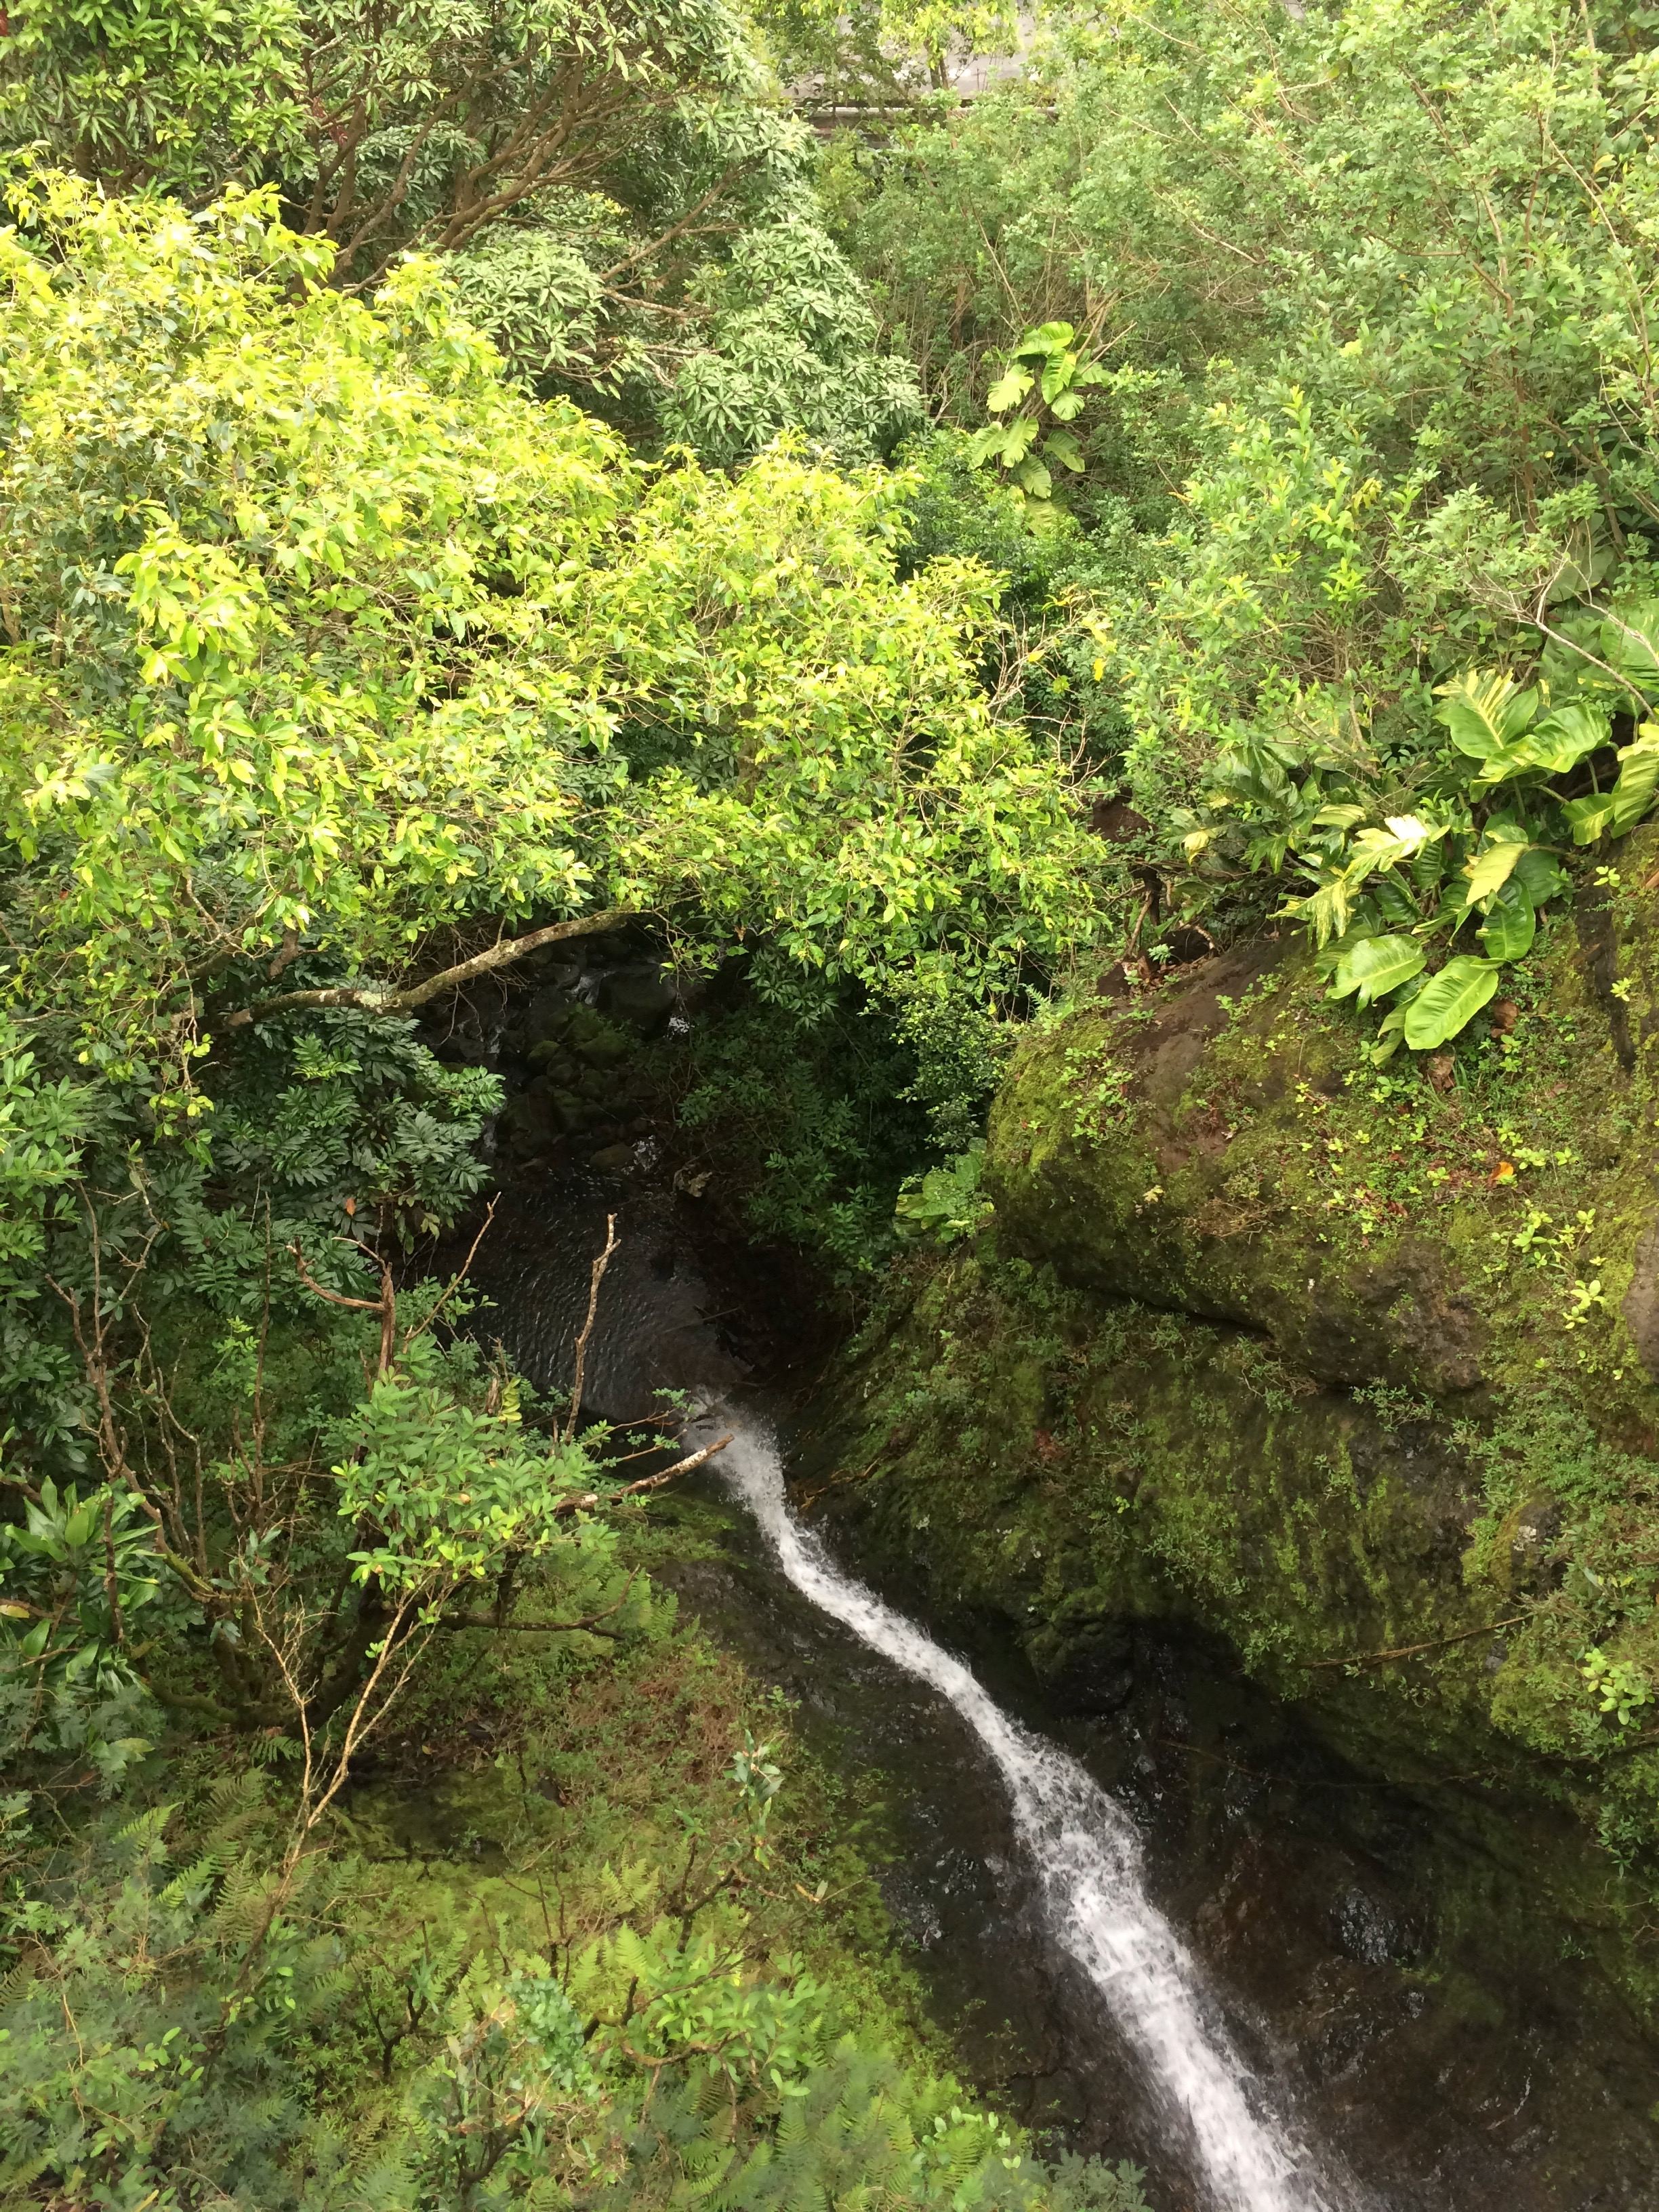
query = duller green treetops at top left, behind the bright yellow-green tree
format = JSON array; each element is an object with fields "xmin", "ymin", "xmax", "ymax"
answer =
[{"xmin": 0, "ymin": 0, "xmax": 918, "ymax": 460}]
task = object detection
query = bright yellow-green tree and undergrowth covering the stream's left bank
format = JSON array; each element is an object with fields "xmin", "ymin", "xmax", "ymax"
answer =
[{"xmin": 0, "ymin": 73, "xmax": 1119, "ymax": 2212}]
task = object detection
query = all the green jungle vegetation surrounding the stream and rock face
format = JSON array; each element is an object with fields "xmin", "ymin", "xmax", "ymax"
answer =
[{"xmin": 0, "ymin": 0, "xmax": 1659, "ymax": 2212}]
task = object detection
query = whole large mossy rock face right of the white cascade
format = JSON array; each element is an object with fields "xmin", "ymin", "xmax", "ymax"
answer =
[{"xmin": 814, "ymin": 832, "xmax": 1659, "ymax": 2026}]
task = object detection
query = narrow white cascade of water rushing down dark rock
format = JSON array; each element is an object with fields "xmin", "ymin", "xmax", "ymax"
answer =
[{"xmin": 710, "ymin": 1411, "xmax": 1349, "ymax": 2212}]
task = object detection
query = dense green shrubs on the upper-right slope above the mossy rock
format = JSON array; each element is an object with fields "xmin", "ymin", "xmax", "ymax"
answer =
[{"xmin": 830, "ymin": 0, "xmax": 1659, "ymax": 1048}]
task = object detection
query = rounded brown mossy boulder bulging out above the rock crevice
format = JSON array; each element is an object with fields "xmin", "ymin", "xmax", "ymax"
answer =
[{"xmin": 984, "ymin": 945, "xmax": 1484, "ymax": 1393}]
